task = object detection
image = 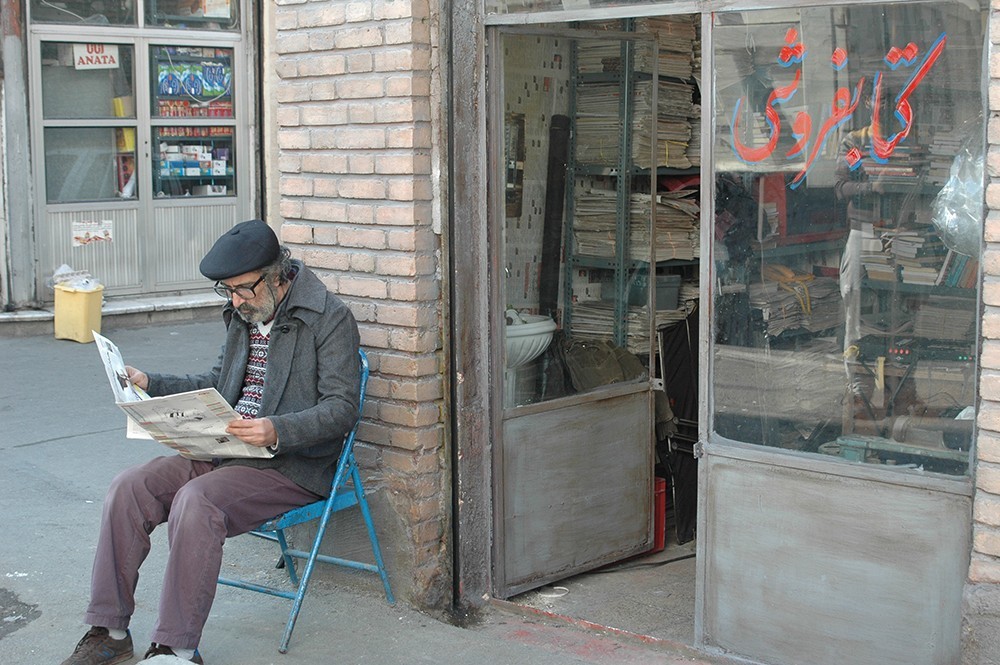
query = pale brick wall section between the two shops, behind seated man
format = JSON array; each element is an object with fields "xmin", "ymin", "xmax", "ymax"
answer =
[{"xmin": 264, "ymin": 0, "xmax": 451, "ymax": 607}]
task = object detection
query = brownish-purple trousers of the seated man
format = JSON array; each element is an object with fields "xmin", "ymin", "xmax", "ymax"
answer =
[{"xmin": 84, "ymin": 456, "xmax": 320, "ymax": 649}]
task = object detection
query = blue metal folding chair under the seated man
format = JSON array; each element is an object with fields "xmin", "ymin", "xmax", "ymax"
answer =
[{"xmin": 219, "ymin": 350, "xmax": 396, "ymax": 653}]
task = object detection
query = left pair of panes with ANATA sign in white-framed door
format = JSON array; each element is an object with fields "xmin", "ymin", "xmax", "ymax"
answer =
[{"xmin": 41, "ymin": 42, "xmax": 137, "ymax": 203}]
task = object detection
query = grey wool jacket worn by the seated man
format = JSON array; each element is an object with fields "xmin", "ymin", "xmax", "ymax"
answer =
[{"xmin": 141, "ymin": 261, "xmax": 361, "ymax": 496}]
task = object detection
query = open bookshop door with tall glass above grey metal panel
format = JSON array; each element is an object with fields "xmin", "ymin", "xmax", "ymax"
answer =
[{"xmin": 491, "ymin": 23, "xmax": 656, "ymax": 598}]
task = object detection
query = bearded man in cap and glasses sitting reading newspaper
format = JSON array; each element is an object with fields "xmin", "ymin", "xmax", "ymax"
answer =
[{"xmin": 63, "ymin": 220, "xmax": 360, "ymax": 665}]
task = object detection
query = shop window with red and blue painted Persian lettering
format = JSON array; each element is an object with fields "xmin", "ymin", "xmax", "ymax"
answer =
[{"xmin": 712, "ymin": 3, "xmax": 986, "ymax": 474}]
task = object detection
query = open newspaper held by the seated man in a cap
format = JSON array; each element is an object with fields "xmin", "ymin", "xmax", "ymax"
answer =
[{"xmin": 94, "ymin": 332, "xmax": 274, "ymax": 460}]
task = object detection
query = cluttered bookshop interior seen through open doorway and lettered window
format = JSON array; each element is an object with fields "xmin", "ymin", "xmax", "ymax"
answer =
[{"xmin": 498, "ymin": 5, "xmax": 982, "ymax": 643}]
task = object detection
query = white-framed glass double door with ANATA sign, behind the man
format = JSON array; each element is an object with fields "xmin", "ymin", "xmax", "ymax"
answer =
[{"xmin": 30, "ymin": 27, "xmax": 252, "ymax": 295}]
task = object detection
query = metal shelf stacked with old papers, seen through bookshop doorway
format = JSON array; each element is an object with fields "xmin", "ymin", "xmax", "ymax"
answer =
[{"xmin": 563, "ymin": 20, "xmax": 700, "ymax": 353}]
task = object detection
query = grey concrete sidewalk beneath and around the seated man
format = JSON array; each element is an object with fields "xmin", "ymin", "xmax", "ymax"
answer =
[{"xmin": 0, "ymin": 321, "xmax": 729, "ymax": 665}]
